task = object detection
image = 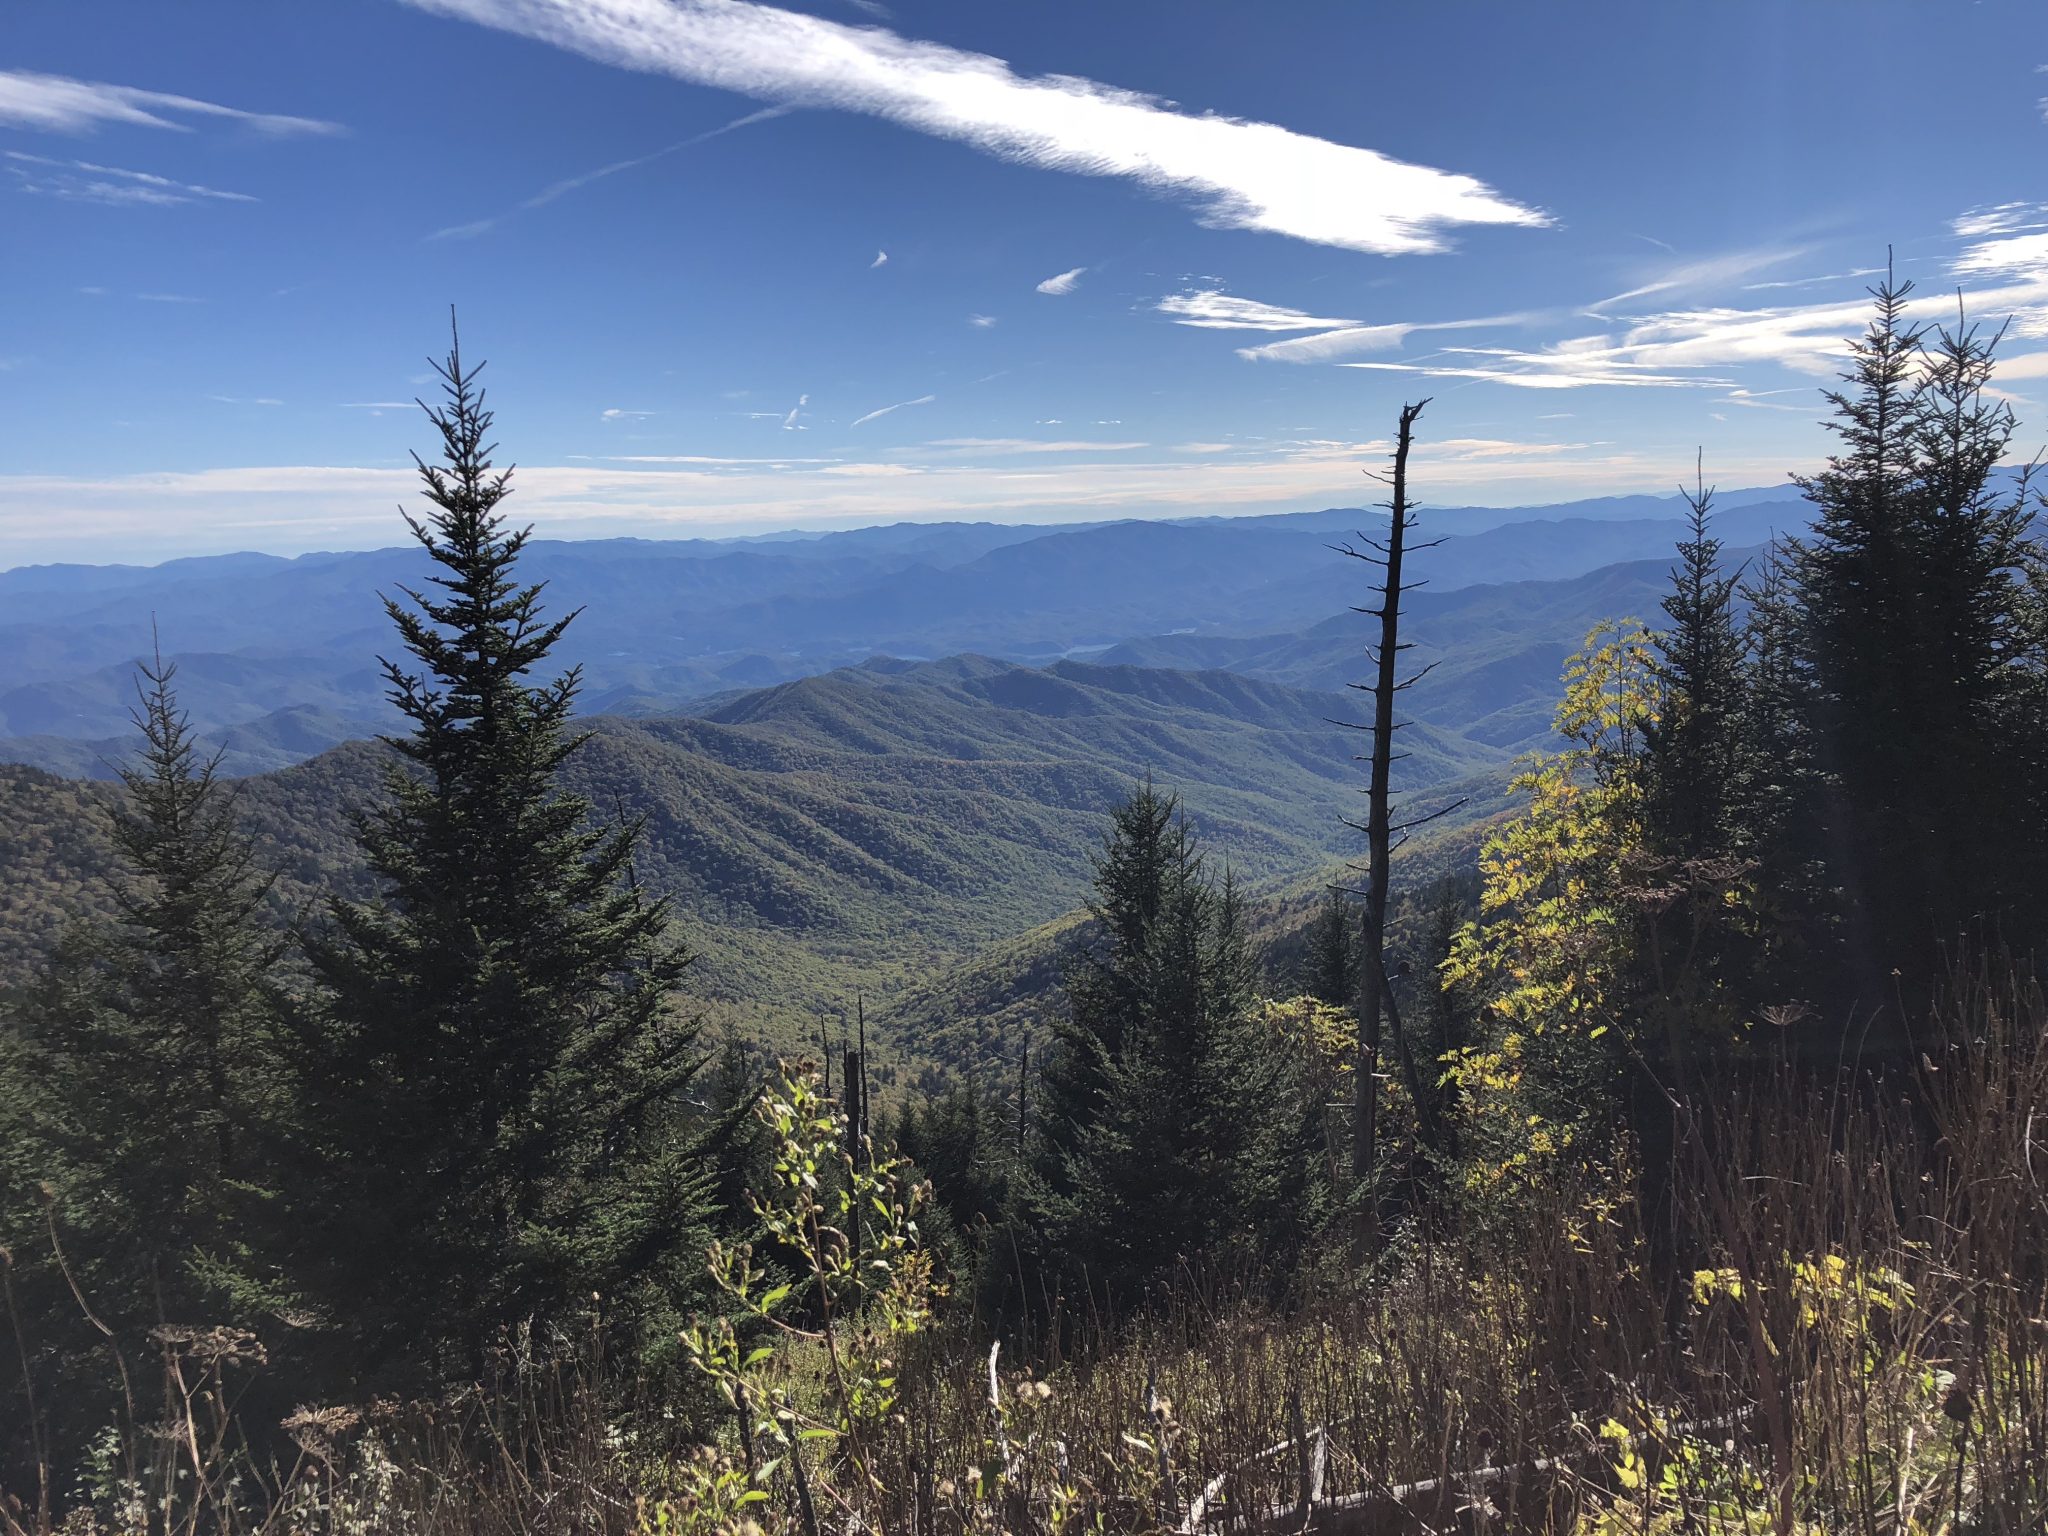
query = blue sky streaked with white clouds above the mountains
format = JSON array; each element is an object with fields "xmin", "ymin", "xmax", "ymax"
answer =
[{"xmin": 0, "ymin": 0, "xmax": 2048, "ymax": 565}]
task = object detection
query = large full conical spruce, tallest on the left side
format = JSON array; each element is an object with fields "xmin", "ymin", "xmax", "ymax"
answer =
[{"xmin": 284, "ymin": 327, "xmax": 707, "ymax": 1376}]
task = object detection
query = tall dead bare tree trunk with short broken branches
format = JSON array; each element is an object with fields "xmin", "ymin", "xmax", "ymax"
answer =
[{"xmin": 1339, "ymin": 399, "xmax": 1452, "ymax": 1247}]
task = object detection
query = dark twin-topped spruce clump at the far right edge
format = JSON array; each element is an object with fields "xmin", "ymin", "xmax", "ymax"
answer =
[{"xmin": 1790, "ymin": 281, "xmax": 2042, "ymax": 1010}]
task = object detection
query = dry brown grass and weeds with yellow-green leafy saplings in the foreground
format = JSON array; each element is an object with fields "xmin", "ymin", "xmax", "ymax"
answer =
[{"xmin": 10, "ymin": 979, "xmax": 2048, "ymax": 1532}]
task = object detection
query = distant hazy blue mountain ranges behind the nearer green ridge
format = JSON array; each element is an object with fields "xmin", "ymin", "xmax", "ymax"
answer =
[{"xmin": 0, "ymin": 487, "xmax": 1804, "ymax": 776}]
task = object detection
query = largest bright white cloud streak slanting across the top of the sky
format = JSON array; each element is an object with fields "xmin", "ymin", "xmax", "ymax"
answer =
[{"xmin": 399, "ymin": 0, "xmax": 1550, "ymax": 254}]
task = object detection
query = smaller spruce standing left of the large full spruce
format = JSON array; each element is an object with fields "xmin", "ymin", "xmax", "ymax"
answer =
[{"xmin": 4, "ymin": 657, "xmax": 283, "ymax": 1323}]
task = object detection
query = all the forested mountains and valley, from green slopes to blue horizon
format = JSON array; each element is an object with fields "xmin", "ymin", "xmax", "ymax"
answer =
[{"xmin": 0, "ymin": 492, "xmax": 1802, "ymax": 1063}]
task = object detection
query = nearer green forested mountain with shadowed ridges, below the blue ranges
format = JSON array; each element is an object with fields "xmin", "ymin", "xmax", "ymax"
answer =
[{"xmin": 0, "ymin": 657, "xmax": 1501, "ymax": 1042}]
